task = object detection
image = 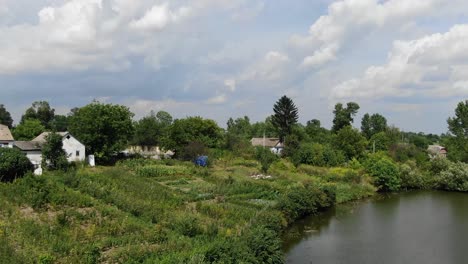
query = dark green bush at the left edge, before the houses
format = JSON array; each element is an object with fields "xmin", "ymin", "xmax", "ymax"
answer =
[{"xmin": 0, "ymin": 148, "xmax": 33, "ymax": 181}]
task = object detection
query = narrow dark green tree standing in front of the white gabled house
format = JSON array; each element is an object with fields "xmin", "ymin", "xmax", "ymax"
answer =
[{"xmin": 42, "ymin": 133, "xmax": 68, "ymax": 170}]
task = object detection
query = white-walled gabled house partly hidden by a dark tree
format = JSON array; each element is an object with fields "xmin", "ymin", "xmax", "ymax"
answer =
[{"xmin": 31, "ymin": 132, "xmax": 86, "ymax": 162}]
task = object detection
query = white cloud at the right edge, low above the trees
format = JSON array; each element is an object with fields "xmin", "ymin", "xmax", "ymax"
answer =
[{"xmin": 332, "ymin": 24, "xmax": 468, "ymax": 99}]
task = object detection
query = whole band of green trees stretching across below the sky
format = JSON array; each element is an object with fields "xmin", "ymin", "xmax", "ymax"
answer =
[{"xmin": 0, "ymin": 96, "xmax": 468, "ymax": 166}]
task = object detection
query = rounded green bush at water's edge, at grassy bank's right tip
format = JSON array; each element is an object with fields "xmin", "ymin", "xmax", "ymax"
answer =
[{"xmin": 364, "ymin": 153, "xmax": 401, "ymax": 192}]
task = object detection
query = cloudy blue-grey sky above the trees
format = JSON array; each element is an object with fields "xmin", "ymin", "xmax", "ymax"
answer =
[{"xmin": 0, "ymin": 0, "xmax": 468, "ymax": 133}]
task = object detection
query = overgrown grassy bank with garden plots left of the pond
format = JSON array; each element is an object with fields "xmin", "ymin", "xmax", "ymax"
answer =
[{"xmin": 0, "ymin": 159, "xmax": 375, "ymax": 263}]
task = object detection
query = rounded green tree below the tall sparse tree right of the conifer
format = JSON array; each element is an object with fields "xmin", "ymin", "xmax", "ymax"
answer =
[{"xmin": 335, "ymin": 126, "xmax": 367, "ymax": 160}]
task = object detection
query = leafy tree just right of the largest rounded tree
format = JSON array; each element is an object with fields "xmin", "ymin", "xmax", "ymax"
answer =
[{"xmin": 133, "ymin": 111, "xmax": 172, "ymax": 146}]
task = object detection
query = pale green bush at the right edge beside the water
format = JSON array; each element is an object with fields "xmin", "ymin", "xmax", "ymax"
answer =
[{"xmin": 435, "ymin": 162, "xmax": 468, "ymax": 192}]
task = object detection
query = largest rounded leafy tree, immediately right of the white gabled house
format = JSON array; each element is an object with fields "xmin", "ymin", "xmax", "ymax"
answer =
[{"xmin": 69, "ymin": 101, "xmax": 133, "ymax": 160}]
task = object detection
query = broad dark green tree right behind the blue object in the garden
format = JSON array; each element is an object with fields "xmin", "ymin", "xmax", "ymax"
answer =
[{"xmin": 165, "ymin": 117, "xmax": 223, "ymax": 156}]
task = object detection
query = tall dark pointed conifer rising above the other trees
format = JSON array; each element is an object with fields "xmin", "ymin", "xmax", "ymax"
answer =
[{"xmin": 271, "ymin": 95, "xmax": 299, "ymax": 142}]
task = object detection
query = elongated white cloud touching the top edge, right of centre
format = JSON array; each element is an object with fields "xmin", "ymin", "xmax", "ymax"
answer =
[{"xmin": 289, "ymin": 0, "xmax": 458, "ymax": 67}]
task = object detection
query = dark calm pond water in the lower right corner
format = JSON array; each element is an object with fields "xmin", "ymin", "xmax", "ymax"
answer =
[{"xmin": 283, "ymin": 192, "xmax": 468, "ymax": 264}]
